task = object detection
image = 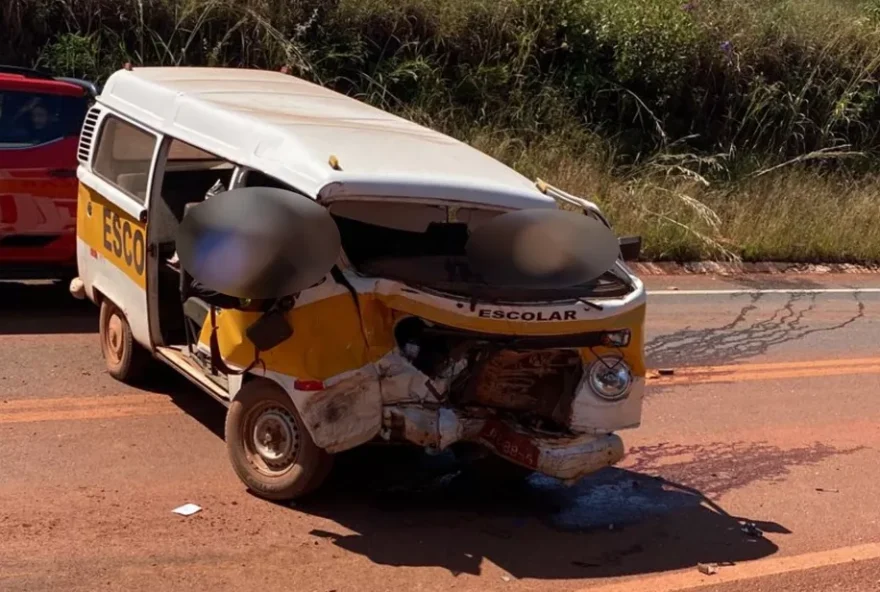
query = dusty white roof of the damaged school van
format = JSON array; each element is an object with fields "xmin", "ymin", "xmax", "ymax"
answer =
[{"xmin": 99, "ymin": 67, "xmax": 555, "ymax": 209}]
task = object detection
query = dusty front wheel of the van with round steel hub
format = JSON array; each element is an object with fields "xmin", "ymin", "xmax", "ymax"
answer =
[{"xmin": 226, "ymin": 379, "xmax": 333, "ymax": 501}]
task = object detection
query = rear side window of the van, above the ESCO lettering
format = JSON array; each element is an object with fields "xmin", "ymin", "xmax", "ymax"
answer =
[{"xmin": 93, "ymin": 115, "xmax": 157, "ymax": 204}]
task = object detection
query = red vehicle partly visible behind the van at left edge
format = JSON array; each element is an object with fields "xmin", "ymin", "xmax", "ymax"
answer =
[{"xmin": 0, "ymin": 66, "xmax": 97, "ymax": 279}]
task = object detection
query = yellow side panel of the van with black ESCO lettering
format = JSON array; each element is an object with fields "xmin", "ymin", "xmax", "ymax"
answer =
[{"xmin": 76, "ymin": 183, "xmax": 147, "ymax": 289}]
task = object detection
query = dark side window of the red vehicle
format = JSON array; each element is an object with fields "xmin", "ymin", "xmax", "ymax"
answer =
[{"xmin": 0, "ymin": 92, "xmax": 88, "ymax": 150}]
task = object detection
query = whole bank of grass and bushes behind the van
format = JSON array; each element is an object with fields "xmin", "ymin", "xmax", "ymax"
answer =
[{"xmin": 6, "ymin": 0, "xmax": 880, "ymax": 262}]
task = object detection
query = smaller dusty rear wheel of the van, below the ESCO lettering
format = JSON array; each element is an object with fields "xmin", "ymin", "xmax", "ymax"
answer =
[{"xmin": 98, "ymin": 299, "xmax": 151, "ymax": 384}]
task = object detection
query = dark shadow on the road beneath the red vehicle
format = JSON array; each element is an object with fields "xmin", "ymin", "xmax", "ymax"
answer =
[{"xmin": 0, "ymin": 281, "xmax": 98, "ymax": 335}]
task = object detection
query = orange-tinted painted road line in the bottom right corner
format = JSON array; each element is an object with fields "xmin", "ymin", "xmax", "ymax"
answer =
[{"xmin": 577, "ymin": 543, "xmax": 880, "ymax": 592}]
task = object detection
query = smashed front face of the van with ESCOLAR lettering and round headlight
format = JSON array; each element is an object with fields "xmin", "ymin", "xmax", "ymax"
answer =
[{"xmin": 358, "ymin": 272, "xmax": 645, "ymax": 481}]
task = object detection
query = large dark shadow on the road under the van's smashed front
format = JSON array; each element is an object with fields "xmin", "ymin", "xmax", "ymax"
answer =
[{"xmin": 286, "ymin": 449, "xmax": 788, "ymax": 579}]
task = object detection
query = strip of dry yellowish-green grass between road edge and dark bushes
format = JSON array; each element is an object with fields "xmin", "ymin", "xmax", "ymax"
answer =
[{"xmin": 488, "ymin": 138, "xmax": 880, "ymax": 263}]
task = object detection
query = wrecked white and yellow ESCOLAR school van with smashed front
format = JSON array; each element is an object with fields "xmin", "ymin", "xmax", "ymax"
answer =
[{"xmin": 71, "ymin": 68, "xmax": 645, "ymax": 499}]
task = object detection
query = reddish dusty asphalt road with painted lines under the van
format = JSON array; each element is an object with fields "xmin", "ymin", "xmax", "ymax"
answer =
[{"xmin": 0, "ymin": 276, "xmax": 880, "ymax": 592}]
